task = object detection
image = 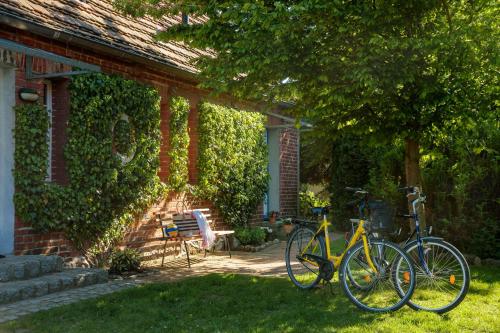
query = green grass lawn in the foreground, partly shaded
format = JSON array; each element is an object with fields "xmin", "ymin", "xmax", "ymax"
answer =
[{"xmin": 0, "ymin": 268, "xmax": 500, "ymax": 333}]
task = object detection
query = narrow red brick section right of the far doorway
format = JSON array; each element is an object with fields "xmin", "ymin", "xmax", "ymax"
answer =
[{"xmin": 280, "ymin": 128, "xmax": 299, "ymax": 217}]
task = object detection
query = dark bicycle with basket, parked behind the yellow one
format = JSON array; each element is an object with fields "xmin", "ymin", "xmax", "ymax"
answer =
[{"xmin": 346, "ymin": 186, "xmax": 470, "ymax": 313}]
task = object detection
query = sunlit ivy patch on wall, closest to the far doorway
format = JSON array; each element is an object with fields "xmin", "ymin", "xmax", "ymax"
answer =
[{"xmin": 198, "ymin": 102, "xmax": 268, "ymax": 226}]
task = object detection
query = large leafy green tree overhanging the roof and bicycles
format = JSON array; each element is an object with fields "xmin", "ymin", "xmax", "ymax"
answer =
[{"xmin": 115, "ymin": 0, "xmax": 500, "ymax": 228}]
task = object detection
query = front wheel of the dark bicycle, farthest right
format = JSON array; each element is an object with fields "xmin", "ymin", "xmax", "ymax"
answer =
[{"xmin": 405, "ymin": 237, "xmax": 470, "ymax": 313}]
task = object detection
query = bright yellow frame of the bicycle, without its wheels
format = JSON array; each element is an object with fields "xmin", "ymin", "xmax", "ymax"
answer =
[{"xmin": 301, "ymin": 214, "xmax": 378, "ymax": 273}]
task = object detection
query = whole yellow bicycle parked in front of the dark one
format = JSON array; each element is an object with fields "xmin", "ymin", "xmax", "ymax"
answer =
[{"xmin": 285, "ymin": 189, "xmax": 416, "ymax": 312}]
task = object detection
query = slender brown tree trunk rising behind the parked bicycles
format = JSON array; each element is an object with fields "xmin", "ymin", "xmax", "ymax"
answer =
[{"xmin": 405, "ymin": 139, "xmax": 425, "ymax": 231}]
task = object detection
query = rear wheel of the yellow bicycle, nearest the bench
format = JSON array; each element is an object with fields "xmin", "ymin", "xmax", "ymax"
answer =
[{"xmin": 285, "ymin": 227, "xmax": 327, "ymax": 289}]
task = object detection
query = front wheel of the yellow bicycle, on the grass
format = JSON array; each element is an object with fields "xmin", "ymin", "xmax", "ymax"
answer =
[{"xmin": 339, "ymin": 240, "xmax": 416, "ymax": 312}]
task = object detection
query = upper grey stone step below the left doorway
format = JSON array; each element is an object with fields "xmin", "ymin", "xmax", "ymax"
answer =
[{"xmin": 0, "ymin": 255, "xmax": 63, "ymax": 283}]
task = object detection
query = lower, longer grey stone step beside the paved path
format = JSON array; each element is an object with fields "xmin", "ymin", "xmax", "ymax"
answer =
[{"xmin": 0, "ymin": 268, "xmax": 108, "ymax": 304}]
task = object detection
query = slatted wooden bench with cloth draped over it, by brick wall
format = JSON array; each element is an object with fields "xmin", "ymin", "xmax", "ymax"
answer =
[{"xmin": 156, "ymin": 208, "xmax": 234, "ymax": 268}]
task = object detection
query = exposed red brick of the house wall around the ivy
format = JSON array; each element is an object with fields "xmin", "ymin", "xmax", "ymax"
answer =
[{"xmin": 0, "ymin": 25, "xmax": 296, "ymax": 256}]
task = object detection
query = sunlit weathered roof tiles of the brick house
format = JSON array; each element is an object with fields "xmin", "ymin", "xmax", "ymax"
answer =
[{"xmin": 0, "ymin": 0, "xmax": 210, "ymax": 73}]
